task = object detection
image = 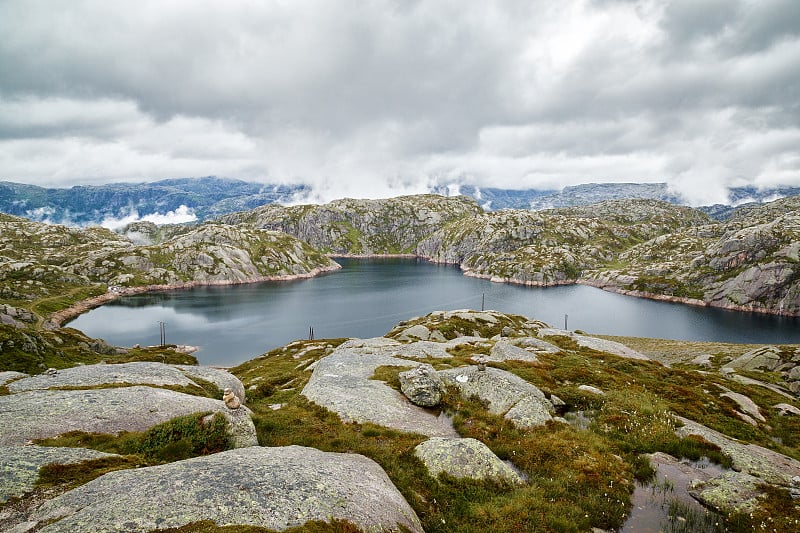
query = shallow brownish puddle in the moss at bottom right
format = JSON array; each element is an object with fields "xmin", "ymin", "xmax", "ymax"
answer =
[{"xmin": 619, "ymin": 454, "xmax": 725, "ymax": 533}]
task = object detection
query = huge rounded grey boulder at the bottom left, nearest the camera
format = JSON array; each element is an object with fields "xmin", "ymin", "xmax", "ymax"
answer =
[{"xmin": 31, "ymin": 446, "xmax": 423, "ymax": 533}]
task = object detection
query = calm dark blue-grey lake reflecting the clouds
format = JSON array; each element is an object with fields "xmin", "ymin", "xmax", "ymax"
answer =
[{"xmin": 69, "ymin": 259, "xmax": 800, "ymax": 366}]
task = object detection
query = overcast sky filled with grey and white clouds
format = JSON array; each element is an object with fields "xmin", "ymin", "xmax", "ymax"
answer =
[{"xmin": 0, "ymin": 0, "xmax": 800, "ymax": 204}]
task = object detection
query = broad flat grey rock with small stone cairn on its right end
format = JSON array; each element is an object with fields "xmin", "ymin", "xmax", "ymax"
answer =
[{"xmin": 0, "ymin": 386, "xmax": 255, "ymax": 445}]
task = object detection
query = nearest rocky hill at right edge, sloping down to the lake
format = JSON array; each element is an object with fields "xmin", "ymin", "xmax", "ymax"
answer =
[{"xmin": 587, "ymin": 197, "xmax": 800, "ymax": 315}]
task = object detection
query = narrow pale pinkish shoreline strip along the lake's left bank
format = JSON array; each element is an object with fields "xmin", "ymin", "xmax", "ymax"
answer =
[{"xmin": 44, "ymin": 264, "xmax": 342, "ymax": 330}]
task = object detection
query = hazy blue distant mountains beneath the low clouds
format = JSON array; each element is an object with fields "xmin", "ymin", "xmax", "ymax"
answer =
[{"xmin": 0, "ymin": 176, "xmax": 800, "ymax": 226}]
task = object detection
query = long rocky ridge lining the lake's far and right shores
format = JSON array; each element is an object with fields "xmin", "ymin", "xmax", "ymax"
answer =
[{"xmin": 220, "ymin": 196, "xmax": 800, "ymax": 315}]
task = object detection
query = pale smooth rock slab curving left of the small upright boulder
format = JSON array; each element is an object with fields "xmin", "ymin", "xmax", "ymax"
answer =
[{"xmin": 302, "ymin": 338, "xmax": 457, "ymax": 437}]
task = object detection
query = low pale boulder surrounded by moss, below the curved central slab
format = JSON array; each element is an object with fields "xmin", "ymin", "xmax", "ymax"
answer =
[{"xmin": 414, "ymin": 437, "xmax": 524, "ymax": 485}]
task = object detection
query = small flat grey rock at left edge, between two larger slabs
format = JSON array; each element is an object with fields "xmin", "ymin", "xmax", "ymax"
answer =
[{"xmin": 0, "ymin": 446, "xmax": 118, "ymax": 503}]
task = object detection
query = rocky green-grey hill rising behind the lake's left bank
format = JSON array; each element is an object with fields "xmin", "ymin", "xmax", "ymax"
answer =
[{"xmin": 0, "ymin": 215, "xmax": 339, "ymax": 328}]
